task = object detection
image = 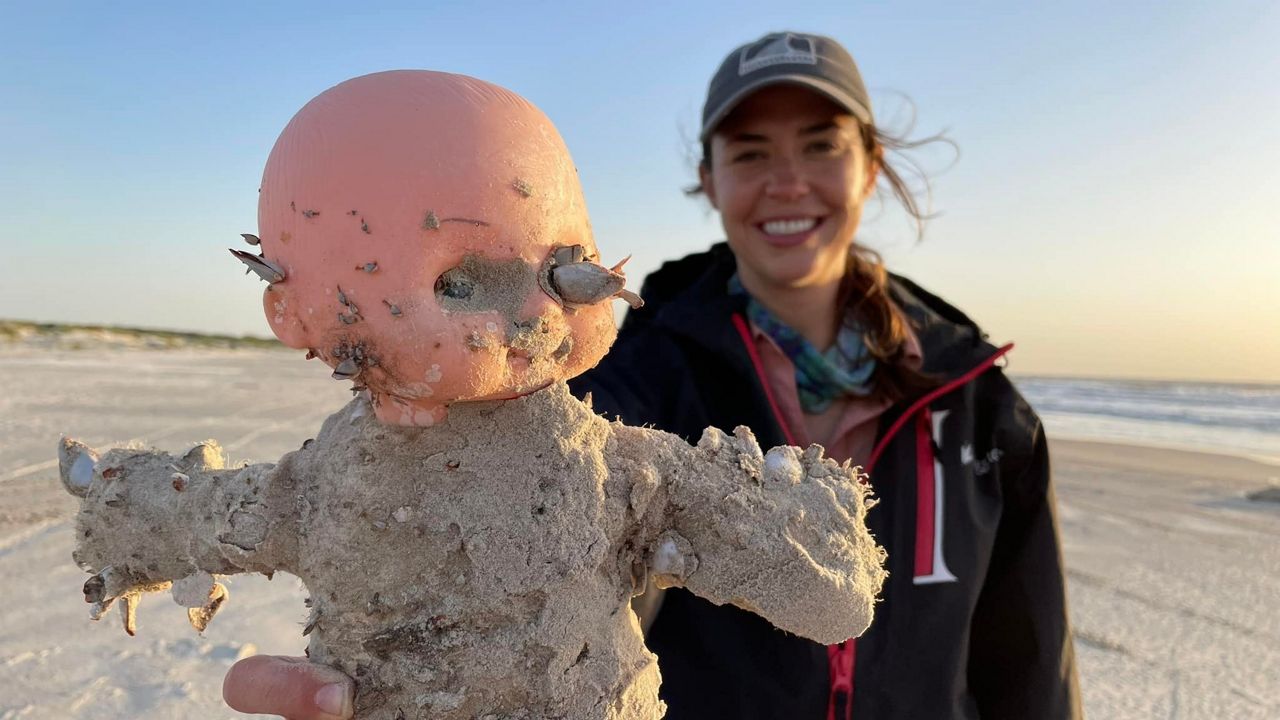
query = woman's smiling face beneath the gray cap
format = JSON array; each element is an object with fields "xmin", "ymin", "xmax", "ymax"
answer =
[{"xmin": 701, "ymin": 85, "xmax": 877, "ymax": 295}]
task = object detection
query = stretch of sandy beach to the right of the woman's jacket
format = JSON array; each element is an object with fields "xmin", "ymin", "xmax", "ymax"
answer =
[{"xmin": 1051, "ymin": 441, "xmax": 1280, "ymax": 720}]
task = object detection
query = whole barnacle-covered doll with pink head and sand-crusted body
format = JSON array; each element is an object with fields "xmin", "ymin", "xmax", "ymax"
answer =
[{"xmin": 60, "ymin": 70, "xmax": 883, "ymax": 719}]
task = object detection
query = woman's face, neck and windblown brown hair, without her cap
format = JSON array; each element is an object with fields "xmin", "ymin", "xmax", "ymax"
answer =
[{"xmin": 689, "ymin": 80, "xmax": 951, "ymax": 397}]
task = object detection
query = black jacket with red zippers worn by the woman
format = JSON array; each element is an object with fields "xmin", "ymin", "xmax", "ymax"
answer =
[{"xmin": 571, "ymin": 245, "xmax": 1080, "ymax": 720}]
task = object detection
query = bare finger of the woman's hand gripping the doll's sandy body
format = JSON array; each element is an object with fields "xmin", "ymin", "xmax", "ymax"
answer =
[{"xmin": 223, "ymin": 655, "xmax": 355, "ymax": 720}]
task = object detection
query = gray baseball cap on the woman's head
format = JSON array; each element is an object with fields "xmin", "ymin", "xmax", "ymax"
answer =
[{"xmin": 699, "ymin": 32, "xmax": 873, "ymax": 142}]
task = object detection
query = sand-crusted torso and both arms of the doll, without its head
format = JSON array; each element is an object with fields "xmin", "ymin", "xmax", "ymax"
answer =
[{"xmin": 64, "ymin": 383, "xmax": 883, "ymax": 720}]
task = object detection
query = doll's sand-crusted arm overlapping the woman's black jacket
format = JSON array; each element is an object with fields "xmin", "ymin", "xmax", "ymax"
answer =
[{"xmin": 613, "ymin": 424, "xmax": 886, "ymax": 644}]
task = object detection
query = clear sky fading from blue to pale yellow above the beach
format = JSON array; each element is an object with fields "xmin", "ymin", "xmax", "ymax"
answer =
[{"xmin": 0, "ymin": 0, "xmax": 1280, "ymax": 382}]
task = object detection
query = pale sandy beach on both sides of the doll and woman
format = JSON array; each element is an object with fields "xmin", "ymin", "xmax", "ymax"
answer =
[{"xmin": 0, "ymin": 346, "xmax": 1280, "ymax": 720}]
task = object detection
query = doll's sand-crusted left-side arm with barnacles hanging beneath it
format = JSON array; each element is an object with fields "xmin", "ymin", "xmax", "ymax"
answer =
[{"xmin": 58, "ymin": 438, "xmax": 298, "ymax": 635}]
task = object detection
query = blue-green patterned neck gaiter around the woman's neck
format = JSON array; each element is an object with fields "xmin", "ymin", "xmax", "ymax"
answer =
[{"xmin": 728, "ymin": 273, "xmax": 876, "ymax": 415}]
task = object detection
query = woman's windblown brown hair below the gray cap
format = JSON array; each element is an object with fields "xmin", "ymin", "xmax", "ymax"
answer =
[{"xmin": 685, "ymin": 114, "xmax": 955, "ymax": 402}]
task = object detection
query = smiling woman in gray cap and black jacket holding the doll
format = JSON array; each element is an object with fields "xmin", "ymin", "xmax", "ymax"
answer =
[{"xmin": 225, "ymin": 33, "xmax": 1080, "ymax": 720}]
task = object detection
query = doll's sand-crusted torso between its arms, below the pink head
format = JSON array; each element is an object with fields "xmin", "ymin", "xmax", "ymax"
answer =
[{"xmin": 286, "ymin": 384, "xmax": 660, "ymax": 719}]
